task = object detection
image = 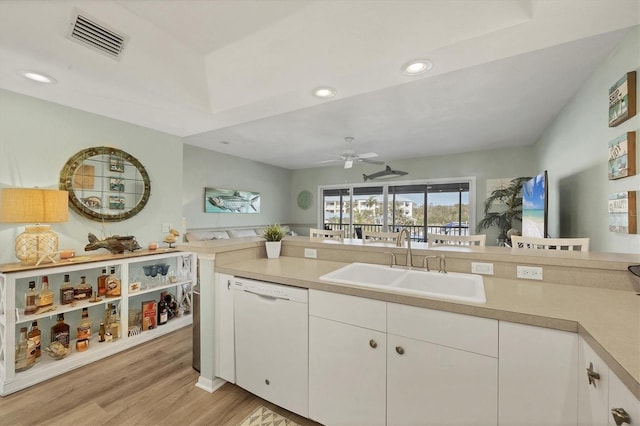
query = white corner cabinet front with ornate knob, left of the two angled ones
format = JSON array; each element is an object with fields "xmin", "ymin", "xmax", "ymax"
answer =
[{"xmin": 578, "ymin": 338, "xmax": 611, "ymax": 426}]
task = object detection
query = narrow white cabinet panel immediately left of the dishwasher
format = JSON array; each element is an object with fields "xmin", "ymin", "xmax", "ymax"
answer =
[{"xmin": 214, "ymin": 273, "xmax": 236, "ymax": 383}]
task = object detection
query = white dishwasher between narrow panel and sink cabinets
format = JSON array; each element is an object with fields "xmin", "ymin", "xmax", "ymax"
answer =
[{"xmin": 233, "ymin": 278, "xmax": 309, "ymax": 417}]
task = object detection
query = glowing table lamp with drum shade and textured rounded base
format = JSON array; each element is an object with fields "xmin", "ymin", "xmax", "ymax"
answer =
[{"xmin": 0, "ymin": 188, "xmax": 69, "ymax": 265}]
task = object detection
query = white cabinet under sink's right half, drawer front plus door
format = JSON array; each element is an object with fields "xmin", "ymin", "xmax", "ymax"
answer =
[{"xmin": 387, "ymin": 303, "xmax": 498, "ymax": 426}]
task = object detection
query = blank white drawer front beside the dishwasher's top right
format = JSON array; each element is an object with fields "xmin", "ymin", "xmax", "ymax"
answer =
[{"xmin": 309, "ymin": 290, "xmax": 387, "ymax": 331}]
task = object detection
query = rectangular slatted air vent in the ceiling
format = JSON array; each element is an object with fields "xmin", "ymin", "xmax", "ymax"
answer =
[{"xmin": 68, "ymin": 11, "xmax": 129, "ymax": 60}]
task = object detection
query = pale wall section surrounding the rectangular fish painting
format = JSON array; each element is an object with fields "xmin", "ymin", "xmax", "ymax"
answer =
[{"xmin": 182, "ymin": 144, "xmax": 291, "ymax": 229}]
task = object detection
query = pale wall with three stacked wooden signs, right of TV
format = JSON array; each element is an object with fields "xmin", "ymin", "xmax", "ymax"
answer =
[{"xmin": 535, "ymin": 27, "xmax": 640, "ymax": 253}]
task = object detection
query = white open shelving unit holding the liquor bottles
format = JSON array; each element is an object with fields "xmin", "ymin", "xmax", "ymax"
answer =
[{"xmin": 0, "ymin": 250, "xmax": 196, "ymax": 395}]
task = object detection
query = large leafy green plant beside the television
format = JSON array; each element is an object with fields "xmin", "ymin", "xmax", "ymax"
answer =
[{"xmin": 478, "ymin": 177, "xmax": 531, "ymax": 245}]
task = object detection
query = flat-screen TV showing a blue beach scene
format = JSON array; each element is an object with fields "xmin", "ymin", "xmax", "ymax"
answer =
[{"xmin": 522, "ymin": 170, "xmax": 549, "ymax": 238}]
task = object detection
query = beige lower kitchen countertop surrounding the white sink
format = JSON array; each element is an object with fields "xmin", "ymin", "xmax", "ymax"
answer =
[{"xmin": 216, "ymin": 257, "xmax": 640, "ymax": 399}]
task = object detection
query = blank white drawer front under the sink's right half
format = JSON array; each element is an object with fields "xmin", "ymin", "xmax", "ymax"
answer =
[{"xmin": 387, "ymin": 303, "xmax": 498, "ymax": 357}]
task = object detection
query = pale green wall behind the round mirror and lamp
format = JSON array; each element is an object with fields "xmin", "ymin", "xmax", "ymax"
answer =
[{"xmin": 0, "ymin": 90, "xmax": 182, "ymax": 263}]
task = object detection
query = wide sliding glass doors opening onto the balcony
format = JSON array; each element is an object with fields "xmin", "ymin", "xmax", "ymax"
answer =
[{"xmin": 320, "ymin": 177, "xmax": 475, "ymax": 241}]
